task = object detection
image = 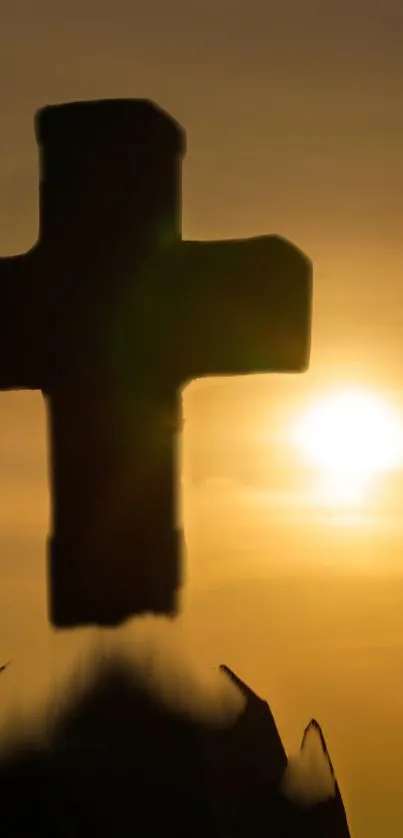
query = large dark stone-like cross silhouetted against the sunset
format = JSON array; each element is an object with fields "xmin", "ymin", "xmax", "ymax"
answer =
[{"xmin": 0, "ymin": 99, "xmax": 312, "ymax": 628}]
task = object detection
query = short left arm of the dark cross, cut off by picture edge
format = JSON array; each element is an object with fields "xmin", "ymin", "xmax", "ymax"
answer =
[{"xmin": 0, "ymin": 253, "xmax": 44, "ymax": 390}]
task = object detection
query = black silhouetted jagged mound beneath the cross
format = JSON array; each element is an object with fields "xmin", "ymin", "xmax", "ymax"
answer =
[{"xmin": 0, "ymin": 666, "xmax": 349, "ymax": 838}]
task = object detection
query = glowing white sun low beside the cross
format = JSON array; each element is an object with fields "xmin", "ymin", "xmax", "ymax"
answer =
[{"xmin": 293, "ymin": 389, "xmax": 403, "ymax": 503}]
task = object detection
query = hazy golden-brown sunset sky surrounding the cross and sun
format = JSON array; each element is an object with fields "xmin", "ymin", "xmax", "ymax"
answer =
[{"xmin": 0, "ymin": 0, "xmax": 403, "ymax": 838}]
